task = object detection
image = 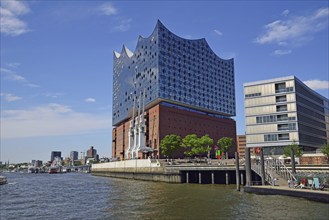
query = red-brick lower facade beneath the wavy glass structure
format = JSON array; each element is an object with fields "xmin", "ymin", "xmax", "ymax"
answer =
[{"xmin": 112, "ymin": 103, "xmax": 237, "ymax": 159}]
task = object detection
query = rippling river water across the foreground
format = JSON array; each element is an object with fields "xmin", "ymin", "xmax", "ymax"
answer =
[{"xmin": 0, "ymin": 173, "xmax": 329, "ymax": 220}]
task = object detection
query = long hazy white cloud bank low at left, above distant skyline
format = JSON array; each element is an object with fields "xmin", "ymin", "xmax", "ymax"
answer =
[{"xmin": 1, "ymin": 103, "xmax": 112, "ymax": 138}]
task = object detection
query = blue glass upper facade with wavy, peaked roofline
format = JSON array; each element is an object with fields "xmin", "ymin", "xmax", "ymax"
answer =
[{"xmin": 113, "ymin": 21, "xmax": 235, "ymax": 125}]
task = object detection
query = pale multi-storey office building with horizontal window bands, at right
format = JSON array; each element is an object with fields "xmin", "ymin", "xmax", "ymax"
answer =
[{"xmin": 244, "ymin": 76, "xmax": 329, "ymax": 154}]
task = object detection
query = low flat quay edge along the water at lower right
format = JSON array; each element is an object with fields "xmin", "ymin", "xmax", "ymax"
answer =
[{"xmin": 244, "ymin": 186, "xmax": 329, "ymax": 203}]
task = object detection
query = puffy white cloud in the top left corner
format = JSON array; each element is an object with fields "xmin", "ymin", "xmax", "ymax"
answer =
[{"xmin": 0, "ymin": 0, "xmax": 30, "ymax": 36}]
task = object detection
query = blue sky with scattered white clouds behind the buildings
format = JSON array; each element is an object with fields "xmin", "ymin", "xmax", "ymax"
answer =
[{"xmin": 0, "ymin": 0, "xmax": 329, "ymax": 162}]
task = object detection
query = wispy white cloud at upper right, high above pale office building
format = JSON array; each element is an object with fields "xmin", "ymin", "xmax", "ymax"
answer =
[{"xmin": 255, "ymin": 8, "xmax": 329, "ymax": 44}]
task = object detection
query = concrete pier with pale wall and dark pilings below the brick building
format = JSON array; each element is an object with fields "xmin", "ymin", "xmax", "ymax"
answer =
[{"xmin": 92, "ymin": 159, "xmax": 244, "ymax": 184}]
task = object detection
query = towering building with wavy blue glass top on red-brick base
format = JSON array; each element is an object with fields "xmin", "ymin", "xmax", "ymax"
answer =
[{"xmin": 112, "ymin": 21, "xmax": 236, "ymax": 159}]
